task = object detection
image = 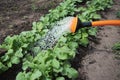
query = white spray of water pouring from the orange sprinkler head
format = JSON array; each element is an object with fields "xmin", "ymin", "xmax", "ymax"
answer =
[{"xmin": 33, "ymin": 17, "xmax": 73, "ymax": 54}]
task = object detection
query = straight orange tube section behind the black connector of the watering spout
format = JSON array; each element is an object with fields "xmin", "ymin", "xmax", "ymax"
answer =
[{"xmin": 92, "ymin": 20, "xmax": 120, "ymax": 27}]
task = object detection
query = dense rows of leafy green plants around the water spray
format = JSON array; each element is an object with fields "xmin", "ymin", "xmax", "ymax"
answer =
[{"xmin": 0, "ymin": 0, "xmax": 111, "ymax": 80}]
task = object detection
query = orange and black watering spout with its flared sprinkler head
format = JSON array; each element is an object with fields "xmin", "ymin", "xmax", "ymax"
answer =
[{"xmin": 70, "ymin": 17, "xmax": 120, "ymax": 33}]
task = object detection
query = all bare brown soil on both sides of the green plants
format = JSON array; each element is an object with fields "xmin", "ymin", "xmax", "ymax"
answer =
[{"xmin": 0, "ymin": 0, "xmax": 120, "ymax": 80}]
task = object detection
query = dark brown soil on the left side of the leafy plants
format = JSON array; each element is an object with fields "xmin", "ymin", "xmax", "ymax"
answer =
[{"xmin": 0, "ymin": 0, "xmax": 62, "ymax": 80}]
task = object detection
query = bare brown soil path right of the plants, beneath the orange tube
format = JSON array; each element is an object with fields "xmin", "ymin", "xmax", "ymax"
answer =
[{"xmin": 78, "ymin": 0, "xmax": 120, "ymax": 80}]
